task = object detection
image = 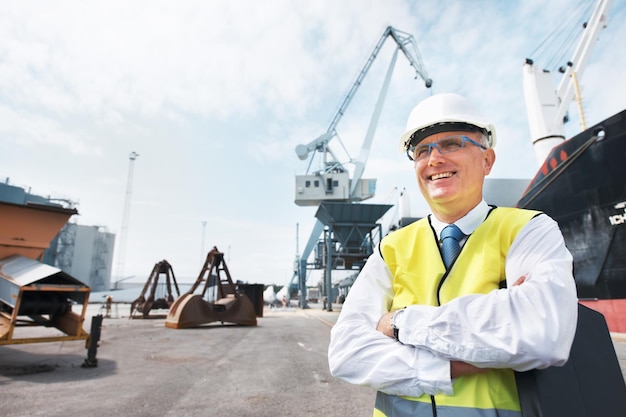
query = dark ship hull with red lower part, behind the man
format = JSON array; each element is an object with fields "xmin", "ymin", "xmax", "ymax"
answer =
[{"xmin": 517, "ymin": 110, "xmax": 626, "ymax": 333}]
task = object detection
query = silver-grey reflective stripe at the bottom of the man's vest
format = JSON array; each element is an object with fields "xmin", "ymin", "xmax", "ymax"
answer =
[{"xmin": 373, "ymin": 392, "xmax": 521, "ymax": 417}]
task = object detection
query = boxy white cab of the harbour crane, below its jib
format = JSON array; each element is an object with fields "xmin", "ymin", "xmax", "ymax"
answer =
[{"xmin": 295, "ymin": 171, "xmax": 376, "ymax": 206}]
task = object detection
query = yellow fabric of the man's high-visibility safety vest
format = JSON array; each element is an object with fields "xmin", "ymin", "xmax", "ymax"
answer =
[{"xmin": 379, "ymin": 208, "xmax": 538, "ymax": 416}]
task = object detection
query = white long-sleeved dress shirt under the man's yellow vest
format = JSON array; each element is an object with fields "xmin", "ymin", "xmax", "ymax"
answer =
[{"xmin": 328, "ymin": 201, "xmax": 577, "ymax": 397}]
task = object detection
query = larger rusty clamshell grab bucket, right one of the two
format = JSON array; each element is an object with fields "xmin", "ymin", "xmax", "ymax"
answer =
[{"xmin": 165, "ymin": 246, "xmax": 257, "ymax": 329}]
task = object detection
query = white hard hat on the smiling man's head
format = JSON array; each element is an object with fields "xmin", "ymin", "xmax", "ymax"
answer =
[{"xmin": 400, "ymin": 93, "xmax": 496, "ymax": 152}]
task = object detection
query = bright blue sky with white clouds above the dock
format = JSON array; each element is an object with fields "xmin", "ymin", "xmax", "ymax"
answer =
[{"xmin": 0, "ymin": 0, "xmax": 626, "ymax": 285}]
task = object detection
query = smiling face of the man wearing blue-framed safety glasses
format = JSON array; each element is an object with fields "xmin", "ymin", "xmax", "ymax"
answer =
[{"xmin": 414, "ymin": 131, "xmax": 495, "ymax": 222}]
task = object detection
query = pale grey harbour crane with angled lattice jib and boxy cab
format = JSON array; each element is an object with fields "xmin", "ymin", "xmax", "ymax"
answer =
[{"xmin": 292, "ymin": 26, "xmax": 432, "ymax": 308}]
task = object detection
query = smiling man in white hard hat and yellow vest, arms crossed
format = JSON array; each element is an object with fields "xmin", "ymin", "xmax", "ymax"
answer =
[{"xmin": 328, "ymin": 94, "xmax": 577, "ymax": 417}]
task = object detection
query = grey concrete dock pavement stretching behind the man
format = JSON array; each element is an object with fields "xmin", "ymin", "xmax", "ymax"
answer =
[{"xmin": 0, "ymin": 306, "xmax": 626, "ymax": 417}]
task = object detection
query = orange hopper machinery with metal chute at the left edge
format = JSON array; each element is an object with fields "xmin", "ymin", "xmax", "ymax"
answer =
[{"xmin": 0, "ymin": 202, "xmax": 102, "ymax": 367}]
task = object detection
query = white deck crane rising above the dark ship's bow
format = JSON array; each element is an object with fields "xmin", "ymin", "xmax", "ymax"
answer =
[{"xmin": 523, "ymin": 0, "xmax": 612, "ymax": 164}]
